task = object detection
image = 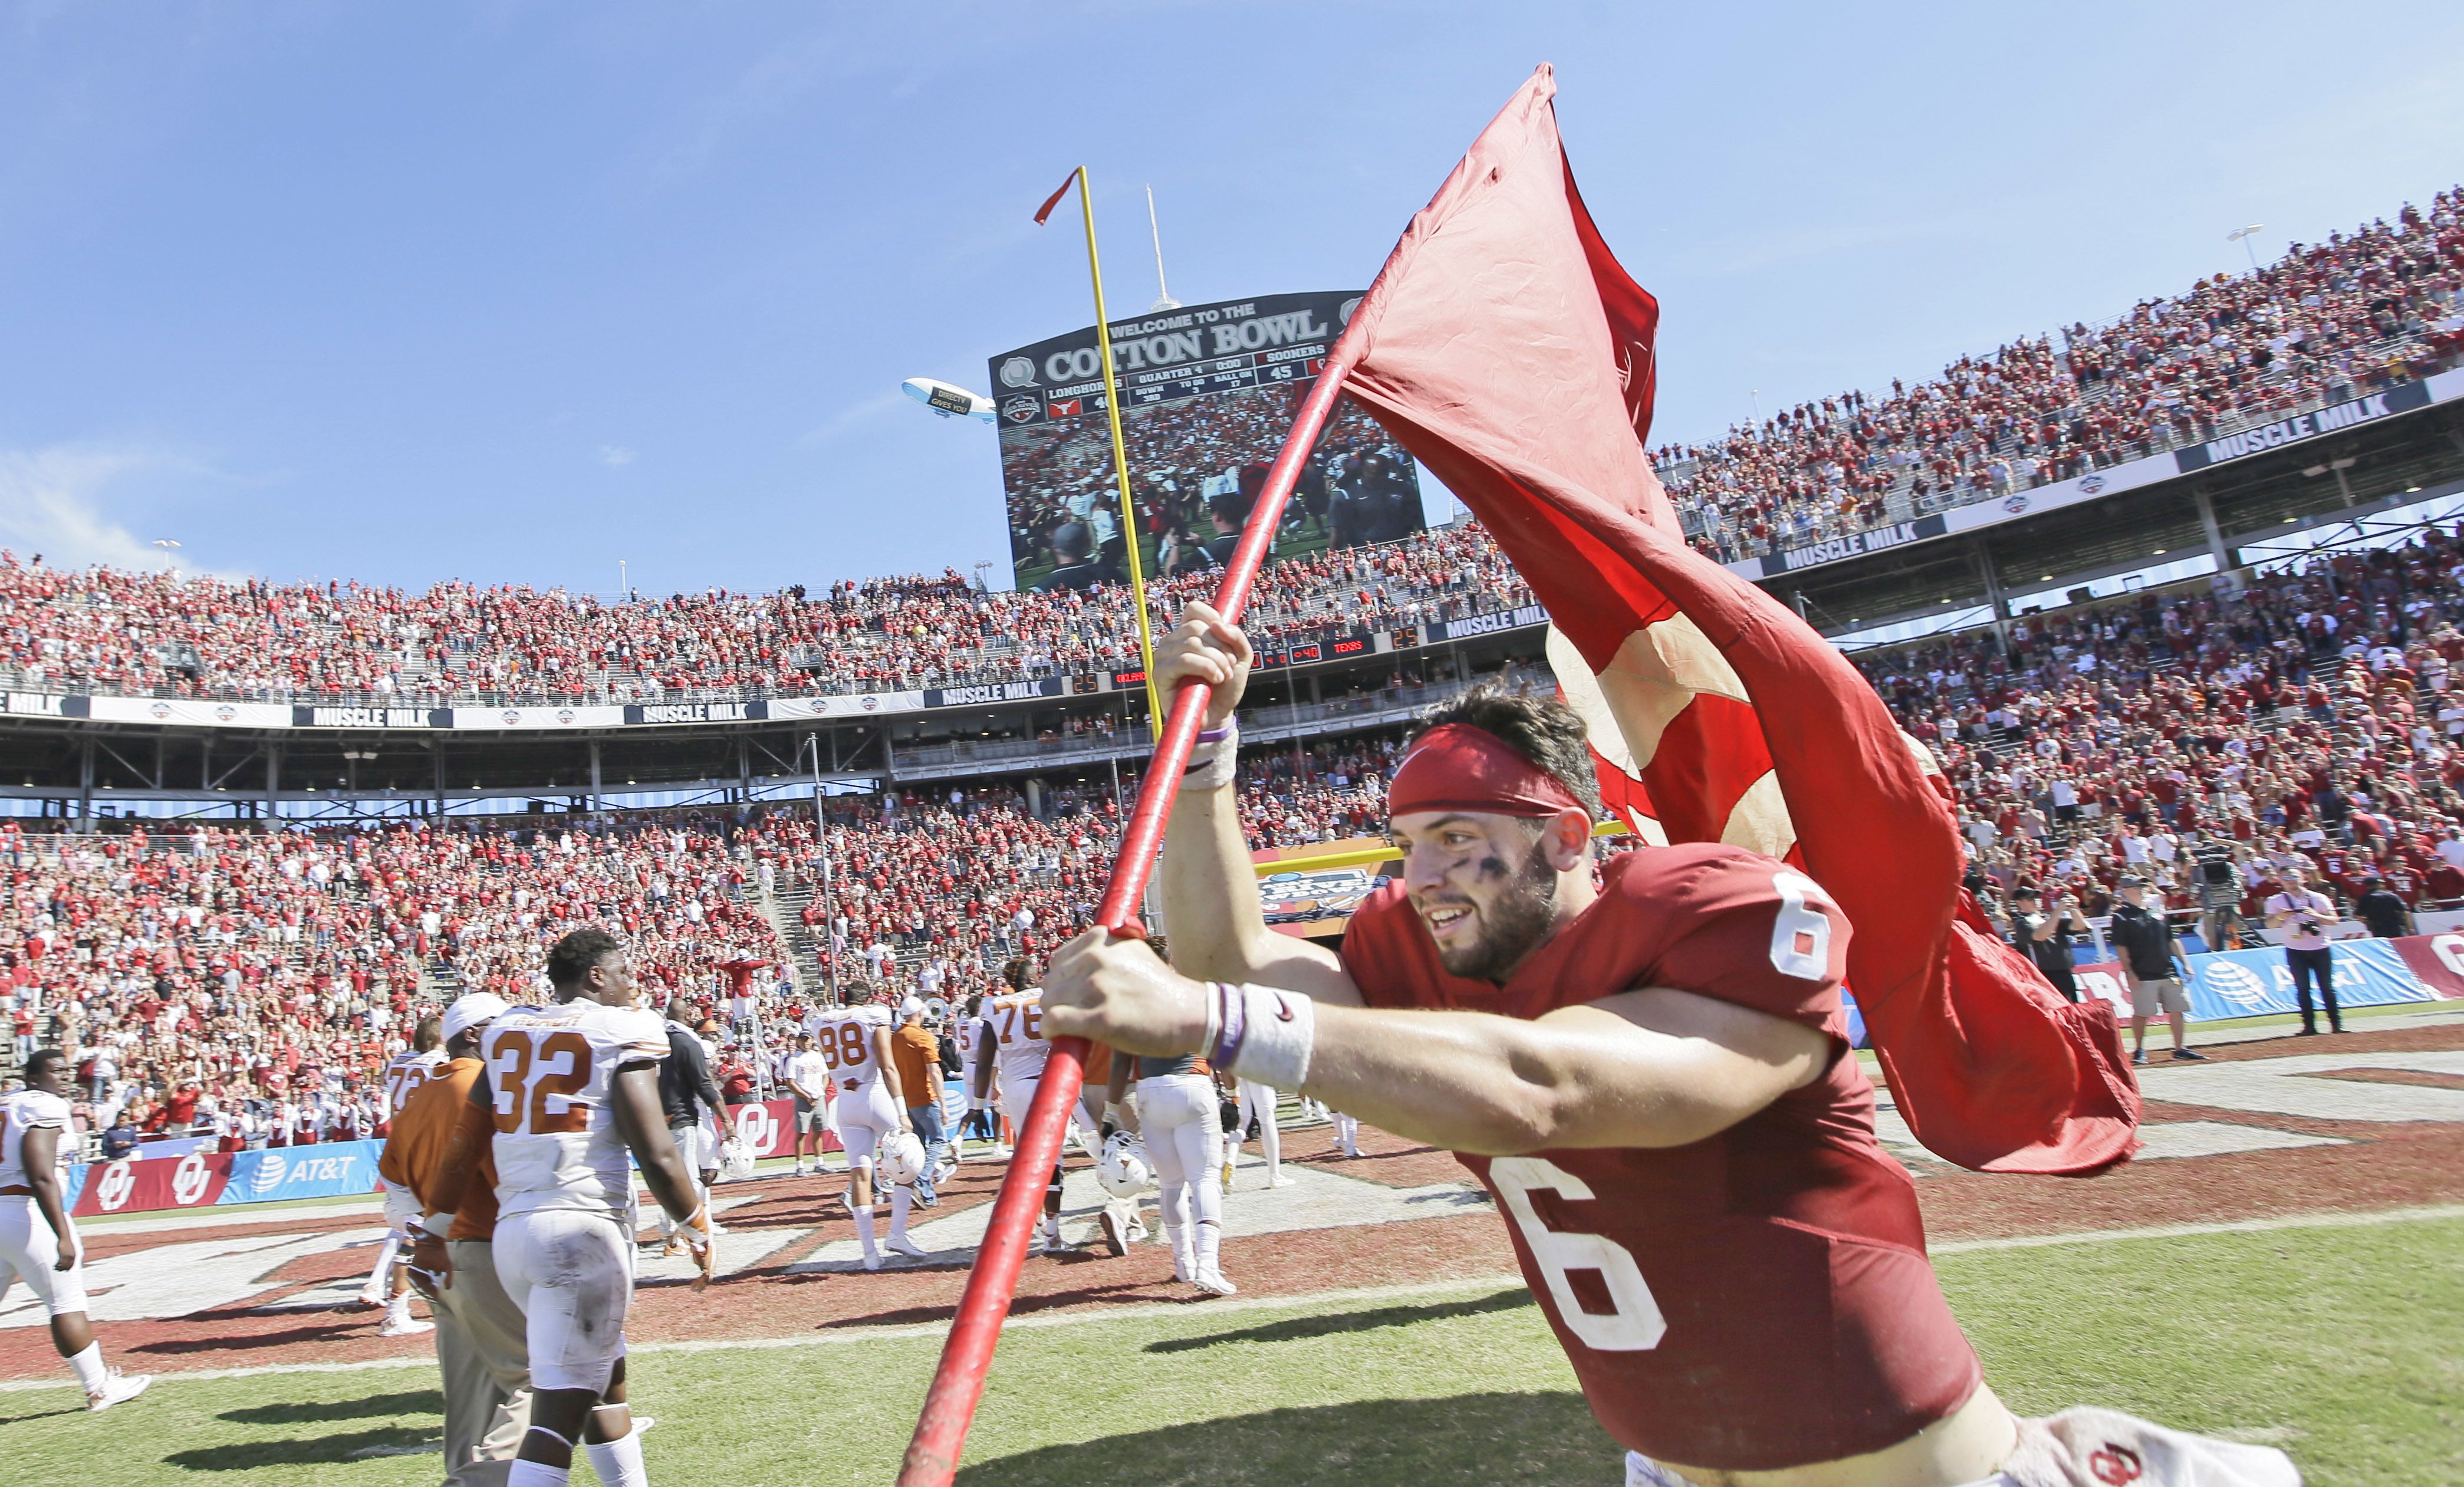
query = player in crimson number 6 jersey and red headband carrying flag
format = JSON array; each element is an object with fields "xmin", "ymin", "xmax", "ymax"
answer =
[{"xmin": 1042, "ymin": 604, "xmax": 2299, "ymax": 1487}]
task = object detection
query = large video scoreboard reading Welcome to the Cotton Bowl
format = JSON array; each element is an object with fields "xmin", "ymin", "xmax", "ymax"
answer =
[{"xmin": 991, "ymin": 291, "xmax": 1422, "ymax": 590}]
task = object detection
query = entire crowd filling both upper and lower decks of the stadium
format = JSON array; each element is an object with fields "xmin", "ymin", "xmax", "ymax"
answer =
[{"xmin": 14, "ymin": 192, "xmax": 2464, "ymax": 1164}]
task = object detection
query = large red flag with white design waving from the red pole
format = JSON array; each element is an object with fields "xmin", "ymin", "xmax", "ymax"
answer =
[{"xmin": 1346, "ymin": 67, "xmax": 2139, "ymax": 1174}]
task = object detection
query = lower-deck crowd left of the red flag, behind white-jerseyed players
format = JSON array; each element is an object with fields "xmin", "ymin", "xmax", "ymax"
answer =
[{"xmin": 0, "ymin": 740, "xmax": 1394, "ymax": 1149}]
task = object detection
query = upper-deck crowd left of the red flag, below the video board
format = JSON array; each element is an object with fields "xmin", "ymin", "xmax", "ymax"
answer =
[{"xmin": 0, "ymin": 528, "xmax": 1530, "ymax": 705}]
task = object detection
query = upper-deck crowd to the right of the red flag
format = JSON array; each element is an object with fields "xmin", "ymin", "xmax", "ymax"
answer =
[{"xmin": 1653, "ymin": 187, "xmax": 2464, "ymax": 562}]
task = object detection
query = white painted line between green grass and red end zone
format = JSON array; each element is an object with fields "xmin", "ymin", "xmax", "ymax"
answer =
[{"xmin": 0, "ymin": 1203, "xmax": 2464, "ymax": 1393}]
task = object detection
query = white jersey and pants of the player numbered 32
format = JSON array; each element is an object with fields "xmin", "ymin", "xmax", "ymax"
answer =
[{"xmin": 481, "ymin": 1001, "xmax": 668, "ymax": 1393}]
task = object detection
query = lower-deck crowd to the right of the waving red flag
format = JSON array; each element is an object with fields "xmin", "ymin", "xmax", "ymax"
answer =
[{"xmin": 1858, "ymin": 528, "xmax": 2464, "ymax": 945}]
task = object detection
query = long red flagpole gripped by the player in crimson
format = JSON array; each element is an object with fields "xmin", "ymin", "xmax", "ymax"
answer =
[{"xmin": 899, "ymin": 323, "xmax": 1377, "ymax": 1487}]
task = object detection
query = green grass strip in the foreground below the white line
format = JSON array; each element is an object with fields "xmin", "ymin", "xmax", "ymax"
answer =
[{"xmin": 0, "ymin": 1220, "xmax": 2464, "ymax": 1487}]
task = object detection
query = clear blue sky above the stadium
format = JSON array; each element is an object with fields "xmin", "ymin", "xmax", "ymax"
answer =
[{"xmin": 0, "ymin": 0, "xmax": 2464, "ymax": 592}]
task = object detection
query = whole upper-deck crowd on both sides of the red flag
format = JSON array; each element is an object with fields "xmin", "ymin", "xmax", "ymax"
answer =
[{"xmin": 0, "ymin": 192, "xmax": 2464, "ymax": 725}]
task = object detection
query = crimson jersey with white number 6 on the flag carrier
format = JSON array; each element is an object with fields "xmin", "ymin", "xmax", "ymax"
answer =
[{"xmin": 1343, "ymin": 843, "xmax": 1981, "ymax": 1470}]
